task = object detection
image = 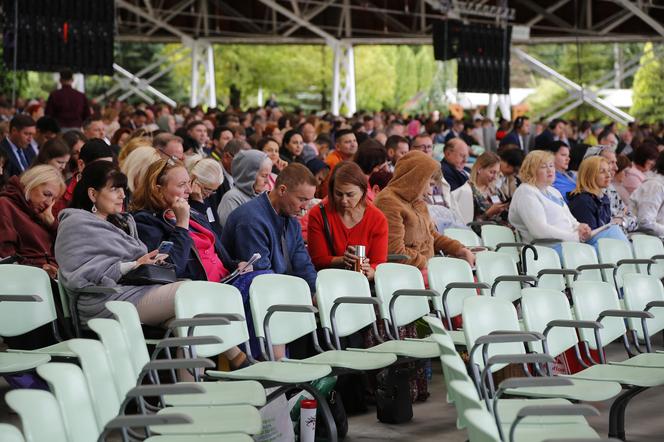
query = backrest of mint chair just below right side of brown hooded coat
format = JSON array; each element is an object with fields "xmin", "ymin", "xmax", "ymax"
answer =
[{"xmin": 427, "ymin": 257, "xmax": 477, "ymax": 317}]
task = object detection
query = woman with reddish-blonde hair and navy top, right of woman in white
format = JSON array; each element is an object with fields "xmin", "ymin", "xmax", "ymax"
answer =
[{"xmin": 569, "ymin": 157, "xmax": 627, "ymax": 245}]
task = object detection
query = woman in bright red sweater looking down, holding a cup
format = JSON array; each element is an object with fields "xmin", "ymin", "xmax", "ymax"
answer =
[{"xmin": 308, "ymin": 161, "xmax": 387, "ymax": 280}]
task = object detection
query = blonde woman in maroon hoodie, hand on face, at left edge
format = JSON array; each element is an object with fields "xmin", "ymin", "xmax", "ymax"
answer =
[{"xmin": 0, "ymin": 164, "xmax": 65, "ymax": 278}]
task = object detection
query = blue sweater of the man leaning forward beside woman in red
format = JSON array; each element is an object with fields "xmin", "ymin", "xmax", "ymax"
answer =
[{"xmin": 221, "ymin": 192, "xmax": 316, "ymax": 293}]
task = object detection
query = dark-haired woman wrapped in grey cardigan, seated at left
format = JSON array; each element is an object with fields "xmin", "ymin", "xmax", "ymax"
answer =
[{"xmin": 55, "ymin": 161, "xmax": 180, "ymax": 325}]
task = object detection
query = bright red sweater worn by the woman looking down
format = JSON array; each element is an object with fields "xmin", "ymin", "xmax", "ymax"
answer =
[{"xmin": 307, "ymin": 199, "xmax": 387, "ymax": 270}]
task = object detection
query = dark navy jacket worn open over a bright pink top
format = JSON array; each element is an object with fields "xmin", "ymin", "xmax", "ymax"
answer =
[{"xmin": 132, "ymin": 209, "xmax": 237, "ymax": 281}]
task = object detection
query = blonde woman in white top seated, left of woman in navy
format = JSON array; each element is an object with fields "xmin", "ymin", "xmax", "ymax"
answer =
[{"xmin": 508, "ymin": 150, "xmax": 591, "ymax": 242}]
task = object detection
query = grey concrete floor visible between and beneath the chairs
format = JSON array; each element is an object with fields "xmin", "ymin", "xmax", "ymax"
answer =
[{"xmin": 0, "ymin": 344, "xmax": 664, "ymax": 442}]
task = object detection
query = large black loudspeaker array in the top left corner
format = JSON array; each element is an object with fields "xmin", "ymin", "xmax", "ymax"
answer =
[{"xmin": 2, "ymin": 0, "xmax": 115, "ymax": 75}]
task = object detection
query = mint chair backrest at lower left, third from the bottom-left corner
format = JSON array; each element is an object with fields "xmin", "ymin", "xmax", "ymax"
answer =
[{"xmin": 37, "ymin": 362, "xmax": 101, "ymax": 442}]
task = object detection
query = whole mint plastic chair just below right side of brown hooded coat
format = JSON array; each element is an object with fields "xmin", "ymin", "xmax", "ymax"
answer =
[{"xmin": 427, "ymin": 257, "xmax": 486, "ymax": 345}]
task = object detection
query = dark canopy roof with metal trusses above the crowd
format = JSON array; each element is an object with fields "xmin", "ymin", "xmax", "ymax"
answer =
[{"xmin": 116, "ymin": 0, "xmax": 664, "ymax": 44}]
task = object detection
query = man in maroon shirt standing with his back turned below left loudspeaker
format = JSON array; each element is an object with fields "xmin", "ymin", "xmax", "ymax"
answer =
[{"xmin": 44, "ymin": 69, "xmax": 92, "ymax": 133}]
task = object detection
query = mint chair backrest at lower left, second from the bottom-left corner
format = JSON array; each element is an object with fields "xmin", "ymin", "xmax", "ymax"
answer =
[{"xmin": 0, "ymin": 390, "xmax": 68, "ymax": 442}]
